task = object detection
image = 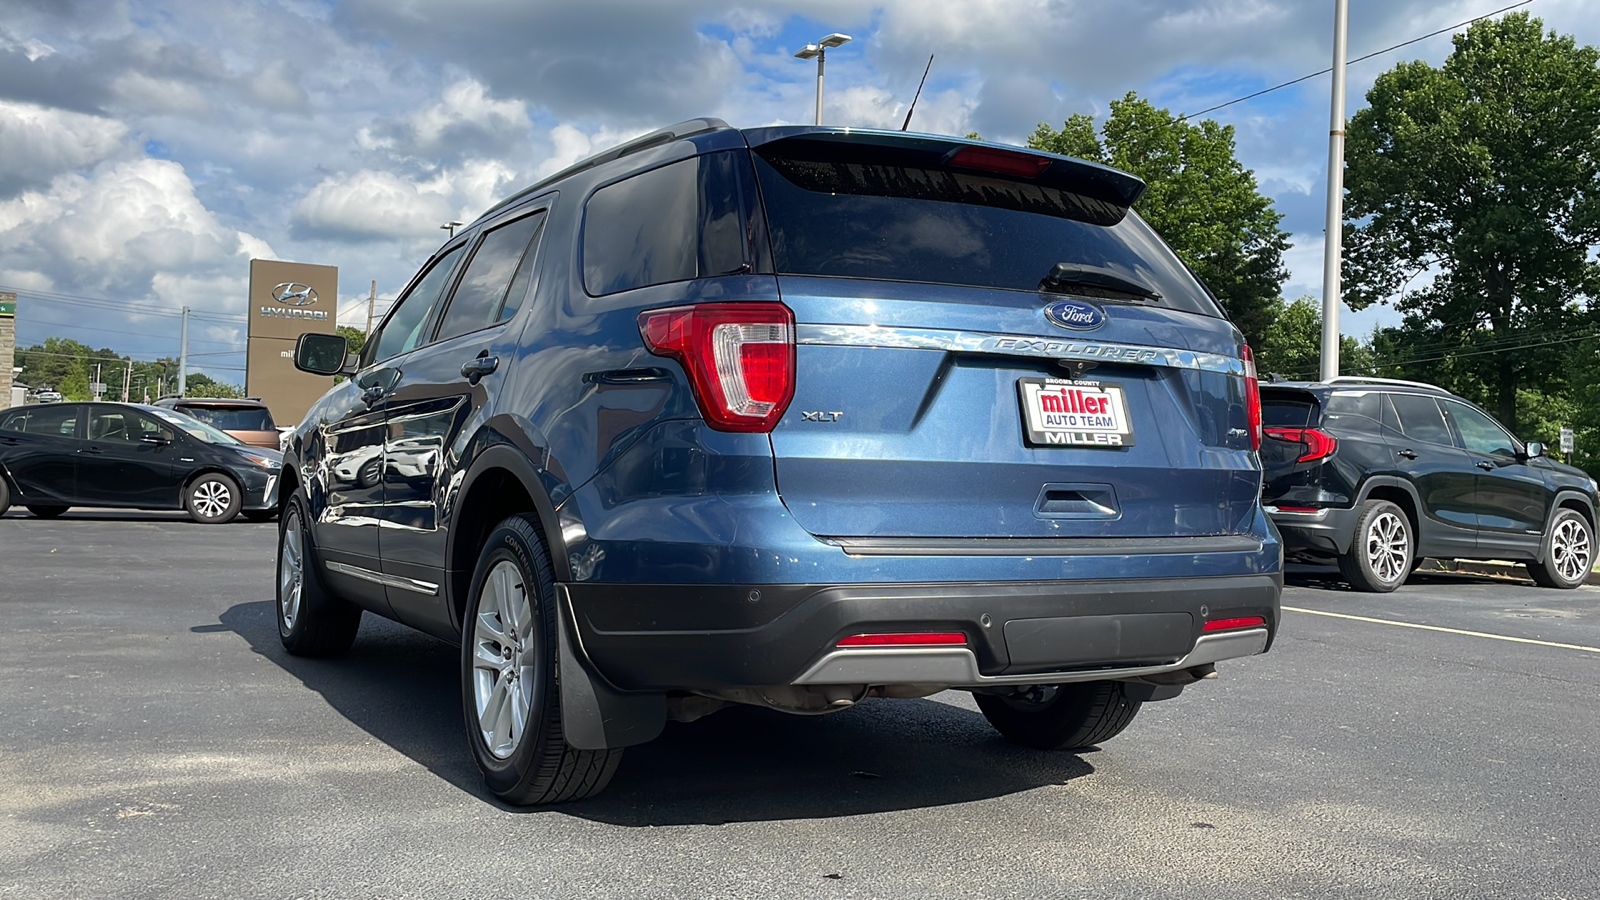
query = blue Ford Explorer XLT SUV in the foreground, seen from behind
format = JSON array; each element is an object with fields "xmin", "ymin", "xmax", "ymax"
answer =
[{"xmin": 277, "ymin": 119, "xmax": 1282, "ymax": 804}]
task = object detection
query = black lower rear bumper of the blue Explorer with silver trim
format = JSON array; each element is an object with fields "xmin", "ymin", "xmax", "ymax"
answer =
[{"xmin": 563, "ymin": 573, "xmax": 1283, "ymax": 690}]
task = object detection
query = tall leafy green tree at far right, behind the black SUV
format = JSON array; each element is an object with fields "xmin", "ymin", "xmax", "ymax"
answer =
[{"xmin": 1344, "ymin": 13, "xmax": 1600, "ymax": 431}]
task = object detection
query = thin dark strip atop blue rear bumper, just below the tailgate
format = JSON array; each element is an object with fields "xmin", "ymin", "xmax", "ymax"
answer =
[{"xmin": 822, "ymin": 535, "xmax": 1262, "ymax": 556}]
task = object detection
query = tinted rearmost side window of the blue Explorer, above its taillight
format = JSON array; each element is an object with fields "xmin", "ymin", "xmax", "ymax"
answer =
[{"xmin": 584, "ymin": 152, "xmax": 752, "ymax": 296}]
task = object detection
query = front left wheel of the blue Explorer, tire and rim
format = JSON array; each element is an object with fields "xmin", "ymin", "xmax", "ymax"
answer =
[{"xmin": 274, "ymin": 492, "xmax": 362, "ymax": 657}]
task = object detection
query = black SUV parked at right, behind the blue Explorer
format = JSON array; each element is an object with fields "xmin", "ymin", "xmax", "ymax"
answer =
[{"xmin": 1261, "ymin": 378, "xmax": 1597, "ymax": 591}]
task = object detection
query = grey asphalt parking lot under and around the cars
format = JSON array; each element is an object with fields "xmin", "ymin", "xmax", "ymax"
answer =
[{"xmin": 0, "ymin": 511, "xmax": 1600, "ymax": 900}]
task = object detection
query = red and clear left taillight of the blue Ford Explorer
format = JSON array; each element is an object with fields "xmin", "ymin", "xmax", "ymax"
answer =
[{"xmin": 638, "ymin": 303, "xmax": 795, "ymax": 431}]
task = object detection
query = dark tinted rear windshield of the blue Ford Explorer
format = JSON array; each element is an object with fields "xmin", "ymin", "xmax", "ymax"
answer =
[{"xmin": 755, "ymin": 139, "xmax": 1221, "ymax": 317}]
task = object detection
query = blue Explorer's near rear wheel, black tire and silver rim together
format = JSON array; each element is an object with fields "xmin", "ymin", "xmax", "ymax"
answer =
[{"xmin": 461, "ymin": 516, "xmax": 622, "ymax": 806}]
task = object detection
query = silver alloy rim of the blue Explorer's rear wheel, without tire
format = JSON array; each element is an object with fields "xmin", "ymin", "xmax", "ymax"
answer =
[{"xmin": 472, "ymin": 559, "xmax": 539, "ymax": 759}]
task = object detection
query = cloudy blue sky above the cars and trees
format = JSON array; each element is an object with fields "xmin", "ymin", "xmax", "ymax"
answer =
[{"xmin": 0, "ymin": 0, "xmax": 1600, "ymax": 383}]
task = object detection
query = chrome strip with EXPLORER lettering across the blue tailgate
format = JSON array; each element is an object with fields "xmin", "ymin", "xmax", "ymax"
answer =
[{"xmin": 795, "ymin": 325, "xmax": 1245, "ymax": 376}]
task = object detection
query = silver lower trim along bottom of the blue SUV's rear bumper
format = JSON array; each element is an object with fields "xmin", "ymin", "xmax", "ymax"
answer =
[{"xmin": 795, "ymin": 628, "xmax": 1267, "ymax": 687}]
